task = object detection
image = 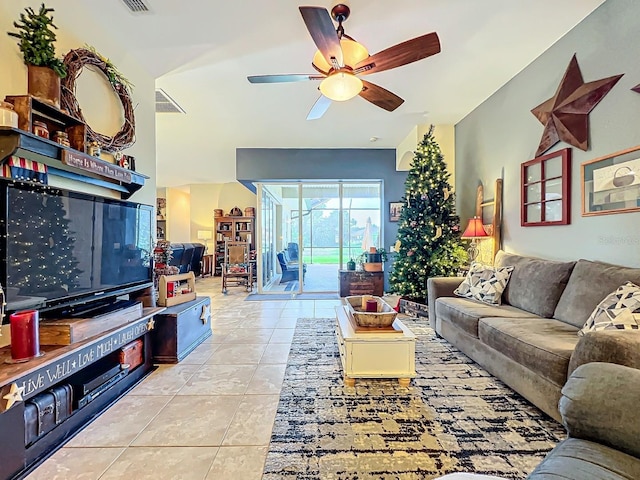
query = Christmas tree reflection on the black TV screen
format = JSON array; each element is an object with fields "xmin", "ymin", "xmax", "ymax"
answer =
[{"xmin": 8, "ymin": 190, "xmax": 82, "ymax": 296}]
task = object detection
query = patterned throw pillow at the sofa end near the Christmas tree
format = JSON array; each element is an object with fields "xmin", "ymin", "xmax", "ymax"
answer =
[{"xmin": 453, "ymin": 263, "xmax": 513, "ymax": 305}]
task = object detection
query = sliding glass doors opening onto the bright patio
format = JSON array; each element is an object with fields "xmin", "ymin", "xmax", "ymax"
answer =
[{"xmin": 257, "ymin": 181, "xmax": 382, "ymax": 295}]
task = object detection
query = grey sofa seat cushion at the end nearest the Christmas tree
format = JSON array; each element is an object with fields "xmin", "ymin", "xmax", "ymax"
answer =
[{"xmin": 436, "ymin": 297, "xmax": 537, "ymax": 338}]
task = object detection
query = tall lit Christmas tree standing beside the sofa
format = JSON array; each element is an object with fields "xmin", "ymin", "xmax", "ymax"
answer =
[{"xmin": 389, "ymin": 125, "xmax": 467, "ymax": 302}]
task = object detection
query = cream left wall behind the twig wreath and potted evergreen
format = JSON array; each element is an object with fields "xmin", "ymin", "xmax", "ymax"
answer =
[{"xmin": 0, "ymin": 0, "xmax": 156, "ymax": 205}]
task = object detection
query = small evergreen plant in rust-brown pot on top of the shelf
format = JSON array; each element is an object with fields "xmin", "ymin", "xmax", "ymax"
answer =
[{"xmin": 7, "ymin": 3, "xmax": 67, "ymax": 108}]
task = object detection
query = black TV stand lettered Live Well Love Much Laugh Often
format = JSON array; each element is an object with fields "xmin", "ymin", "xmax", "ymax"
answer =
[{"xmin": 0, "ymin": 307, "xmax": 165, "ymax": 480}]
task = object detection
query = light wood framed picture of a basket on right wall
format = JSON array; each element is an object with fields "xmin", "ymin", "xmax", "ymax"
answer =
[{"xmin": 580, "ymin": 145, "xmax": 640, "ymax": 217}]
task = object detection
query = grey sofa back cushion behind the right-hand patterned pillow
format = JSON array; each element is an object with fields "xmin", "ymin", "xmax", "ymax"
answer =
[{"xmin": 556, "ymin": 260, "xmax": 640, "ymax": 328}]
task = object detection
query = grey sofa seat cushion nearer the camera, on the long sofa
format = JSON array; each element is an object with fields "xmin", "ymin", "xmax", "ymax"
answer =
[{"xmin": 478, "ymin": 318, "xmax": 578, "ymax": 387}]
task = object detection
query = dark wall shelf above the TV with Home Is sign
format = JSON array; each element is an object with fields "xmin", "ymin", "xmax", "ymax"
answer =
[{"xmin": 0, "ymin": 127, "xmax": 149, "ymax": 199}]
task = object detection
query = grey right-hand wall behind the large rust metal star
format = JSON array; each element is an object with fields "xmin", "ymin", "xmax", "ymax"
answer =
[{"xmin": 455, "ymin": 0, "xmax": 640, "ymax": 267}]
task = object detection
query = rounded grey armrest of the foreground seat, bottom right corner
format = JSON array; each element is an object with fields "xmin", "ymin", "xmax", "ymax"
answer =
[{"xmin": 559, "ymin": 362, "xmax": 640, "ymax": 457}]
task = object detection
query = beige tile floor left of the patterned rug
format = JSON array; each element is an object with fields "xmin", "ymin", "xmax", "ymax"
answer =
[{"xmin": 27, "ymin": 277, "xmax": 340, "ymax": 480}]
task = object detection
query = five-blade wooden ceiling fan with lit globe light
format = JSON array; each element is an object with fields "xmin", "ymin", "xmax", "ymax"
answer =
[{"xmin": 247, "ymin": 4, "xmax": 440, "ymax": 120}]
